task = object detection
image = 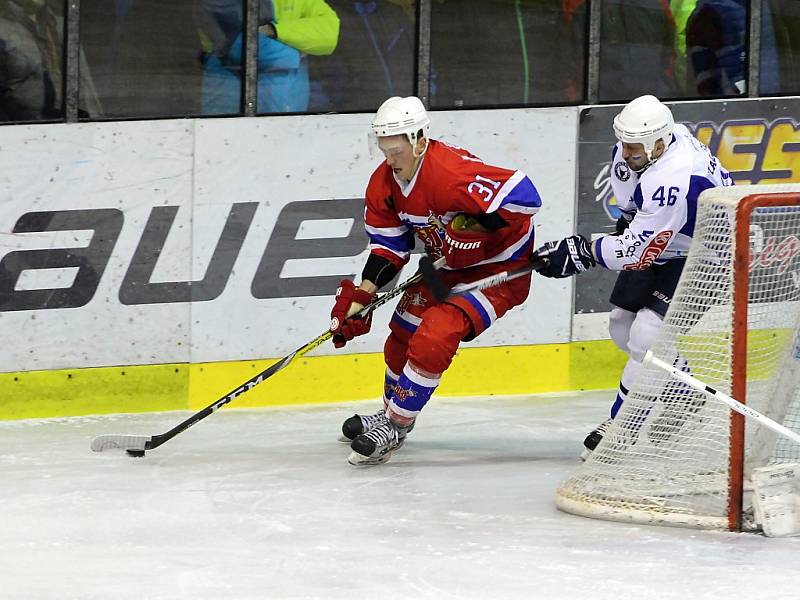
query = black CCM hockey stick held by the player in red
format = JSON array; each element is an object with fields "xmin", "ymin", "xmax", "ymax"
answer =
[{"xmin": 91, "ymin": 258, "xmax": 444, "ymax": 457}]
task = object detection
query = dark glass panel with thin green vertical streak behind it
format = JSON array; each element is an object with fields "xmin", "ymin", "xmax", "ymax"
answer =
[{"xmin": 430, "ymin": 0, "xmax": 588, "ymax": 108}]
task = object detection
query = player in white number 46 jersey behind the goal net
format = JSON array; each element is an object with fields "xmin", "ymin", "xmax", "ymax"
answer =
[{"xmin": 534, "ymin": 95, "xmax": 733, "ymax": 458}]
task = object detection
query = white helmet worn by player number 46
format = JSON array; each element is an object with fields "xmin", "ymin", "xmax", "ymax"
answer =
[{"xmin": 614, "ymin": 95, "xmax": 675, "ymax": 162}]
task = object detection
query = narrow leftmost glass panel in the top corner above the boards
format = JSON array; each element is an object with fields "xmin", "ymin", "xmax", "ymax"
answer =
[{"xmin": 0, "ymin": 0, "xmax": 64, "ymax": 122}]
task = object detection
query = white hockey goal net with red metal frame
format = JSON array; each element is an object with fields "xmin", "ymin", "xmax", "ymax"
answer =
[{"xmin": 556, "ymin": 184, "xmax": 800, "ymax": 530}]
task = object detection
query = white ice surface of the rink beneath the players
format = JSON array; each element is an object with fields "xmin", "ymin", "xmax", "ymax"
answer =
[{"xmin": 0, "ymin": 392, "xmax": 800, "ymax": 600}]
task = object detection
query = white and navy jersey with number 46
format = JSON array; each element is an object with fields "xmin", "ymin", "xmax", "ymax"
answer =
[{"xmin": 593, "ymin": 124, "xmax": 733, "ymax": 271}]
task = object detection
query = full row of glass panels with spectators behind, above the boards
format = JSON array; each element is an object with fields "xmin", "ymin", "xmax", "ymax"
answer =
[{"xmin": 0, "ymin": 0, "xmax": 800, "ymax": 123}]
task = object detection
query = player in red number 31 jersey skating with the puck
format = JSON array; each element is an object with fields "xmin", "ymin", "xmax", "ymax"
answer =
[{"xmin": 331, "ymin": 96, "xmax": 541, "ymax": 465}]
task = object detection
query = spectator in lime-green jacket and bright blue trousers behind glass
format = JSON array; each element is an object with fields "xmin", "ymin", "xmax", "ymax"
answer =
[{"xmin": 199, "ymin": 0, "xmax": 339, "ymax": 114}]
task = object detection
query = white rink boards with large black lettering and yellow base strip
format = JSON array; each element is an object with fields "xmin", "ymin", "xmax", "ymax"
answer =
[{"xmin": 0, "ymin": 97, "xmax": 800, "ymax": 418}]
